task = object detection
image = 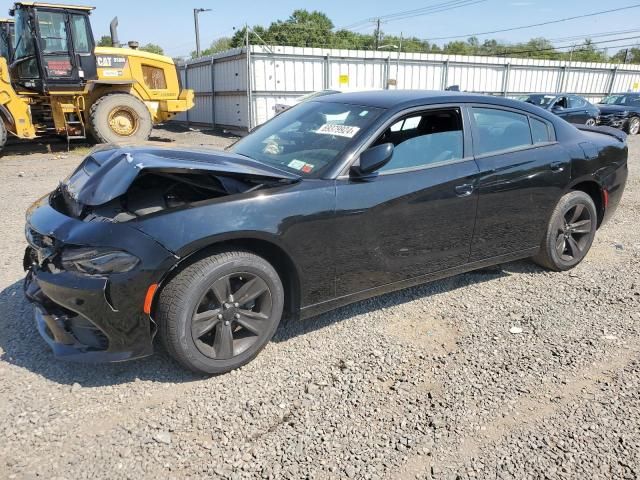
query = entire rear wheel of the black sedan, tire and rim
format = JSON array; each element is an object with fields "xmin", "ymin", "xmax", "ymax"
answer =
[{"xmin": 533, "ymin": 191, "xmax": 598, "ymax": 272}]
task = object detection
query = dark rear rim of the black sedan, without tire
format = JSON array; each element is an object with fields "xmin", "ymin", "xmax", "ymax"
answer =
[{"xmin": 555, "ymin": 203, "xmax": 594, "ymax": 262}]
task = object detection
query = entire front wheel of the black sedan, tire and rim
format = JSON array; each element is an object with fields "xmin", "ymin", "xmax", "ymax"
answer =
[{"xmin": 155, "ymin": 251, "xmax": 284, "ymax": 374}]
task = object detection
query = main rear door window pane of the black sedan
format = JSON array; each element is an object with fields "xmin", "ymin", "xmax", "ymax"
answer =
[{"xmin": 473, "ymin": 107, "xmax": 532, "ymax": 155}]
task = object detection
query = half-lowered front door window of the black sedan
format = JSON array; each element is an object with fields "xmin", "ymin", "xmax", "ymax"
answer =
[{"xmin": 374, "ymin": 108, "xmax": 464, "ymax": 172}]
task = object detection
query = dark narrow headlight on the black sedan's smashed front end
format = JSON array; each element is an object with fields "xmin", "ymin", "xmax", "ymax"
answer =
[{"xmin": 61, "ymin": 247, "xmax": 140, "ymax": 274}]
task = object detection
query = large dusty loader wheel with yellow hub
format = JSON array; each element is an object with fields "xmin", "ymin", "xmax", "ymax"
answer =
[{"xmin": 89, "ymin": 93, "xmax": 153, "ymax": 143}]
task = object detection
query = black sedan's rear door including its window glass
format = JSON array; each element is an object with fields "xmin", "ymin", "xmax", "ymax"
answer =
[{"xmin": 470, "ymin": 105, "xmax": 570, "ymax": 262}]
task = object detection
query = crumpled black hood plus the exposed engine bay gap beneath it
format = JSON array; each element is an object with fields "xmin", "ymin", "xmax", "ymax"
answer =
[{"xmin": 51, "ymin": 147, "xmax": 299, "ymax": 223}]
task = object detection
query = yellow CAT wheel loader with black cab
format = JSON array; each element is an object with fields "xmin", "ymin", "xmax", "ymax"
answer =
[{"xmin": 0, "ymin": 2, "xmax": 193, "ymax": 148}]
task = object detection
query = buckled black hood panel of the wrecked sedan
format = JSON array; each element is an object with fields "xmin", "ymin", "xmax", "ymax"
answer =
[{"xmin": 62, "ymin": 145, "xmax": 300, "ymax": 206}]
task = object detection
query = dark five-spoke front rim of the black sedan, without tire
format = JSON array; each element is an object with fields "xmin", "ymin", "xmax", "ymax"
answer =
[{"xmin": 191, "ymin": 272, "xmax": 277, "ymax": 360}]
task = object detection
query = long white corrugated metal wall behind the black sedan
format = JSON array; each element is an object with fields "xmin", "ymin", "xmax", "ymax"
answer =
[{"xmin": 176, "ymin": 45, "xmax": 640, "ymax": 129}]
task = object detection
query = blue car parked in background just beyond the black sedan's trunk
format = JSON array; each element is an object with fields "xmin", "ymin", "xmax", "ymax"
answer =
[{"xmin": 518, "ymin": 93, "xmax": 600, "ymax": 126}]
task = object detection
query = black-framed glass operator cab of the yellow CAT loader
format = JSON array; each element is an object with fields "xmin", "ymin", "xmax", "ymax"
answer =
[{"xmin": 10, "ymin": 2, "xmax": 97, "ymax": 94}]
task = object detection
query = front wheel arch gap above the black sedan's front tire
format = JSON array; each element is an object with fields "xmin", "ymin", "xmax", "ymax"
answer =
[{"xmin": 151, "ymin": 234, "xmax": 302, "ymax": 318}]
